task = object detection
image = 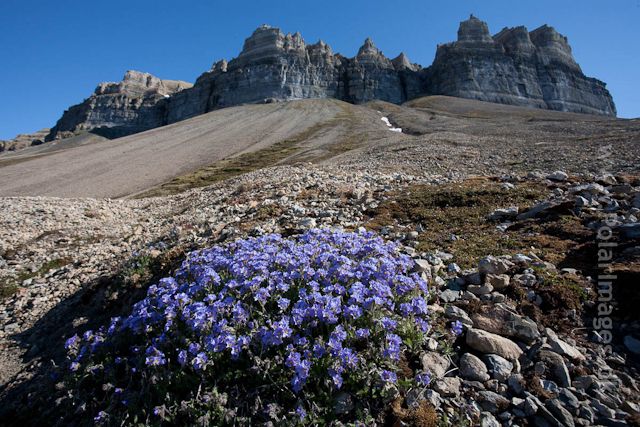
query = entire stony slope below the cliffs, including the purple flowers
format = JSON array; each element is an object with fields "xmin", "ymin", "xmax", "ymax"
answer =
[{"xmin": 0, "ymin": 96, "xmax": 640, "ymax": 427}]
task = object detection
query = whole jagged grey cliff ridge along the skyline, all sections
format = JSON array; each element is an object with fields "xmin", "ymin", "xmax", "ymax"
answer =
[{"xmin": 47, "ymin": 15, "xmax": 616, "ymax": 141}]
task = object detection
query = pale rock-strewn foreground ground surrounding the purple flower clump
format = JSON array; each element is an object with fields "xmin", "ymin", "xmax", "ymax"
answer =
[{"xmin": 0, "ymin": 160, "xmax": 640, "ymax": 426}]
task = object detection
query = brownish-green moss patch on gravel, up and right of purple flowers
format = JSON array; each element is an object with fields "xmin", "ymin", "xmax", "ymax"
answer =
[{"xmin": 366, "ymin": 180, "xmax": 545, "ymax": 268}]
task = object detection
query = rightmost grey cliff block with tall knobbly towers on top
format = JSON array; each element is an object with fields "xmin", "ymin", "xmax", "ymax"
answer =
[{"xmin": 423, "ymin": 16, "xmax": 616, "ymax": 116}]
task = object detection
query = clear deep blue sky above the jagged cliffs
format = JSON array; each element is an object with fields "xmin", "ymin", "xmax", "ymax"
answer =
[{"xmin": 0, "ymin": 0, "xmax": 640, "ymax": 139}]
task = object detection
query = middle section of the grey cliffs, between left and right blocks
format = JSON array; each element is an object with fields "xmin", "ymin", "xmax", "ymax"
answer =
[{"xmin": 168, "ymin": 25, "xmax": 419, "ymax": 123}]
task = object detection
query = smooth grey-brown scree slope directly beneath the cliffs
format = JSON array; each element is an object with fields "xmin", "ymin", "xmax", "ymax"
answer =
[{"xmin": 0, "ymin": 96, "xmax": 640, "ymax": 198}]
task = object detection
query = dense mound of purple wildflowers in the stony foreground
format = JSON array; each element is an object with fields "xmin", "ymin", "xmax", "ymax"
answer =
[{"xmin": 66, "ymin": 230, "xmax": 436, "ymax": 419}]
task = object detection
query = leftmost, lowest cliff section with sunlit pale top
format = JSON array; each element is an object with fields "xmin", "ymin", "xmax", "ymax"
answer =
[{"xmin": 46, "ymin": 71, "xmax": 193, "ymax": 141}]
